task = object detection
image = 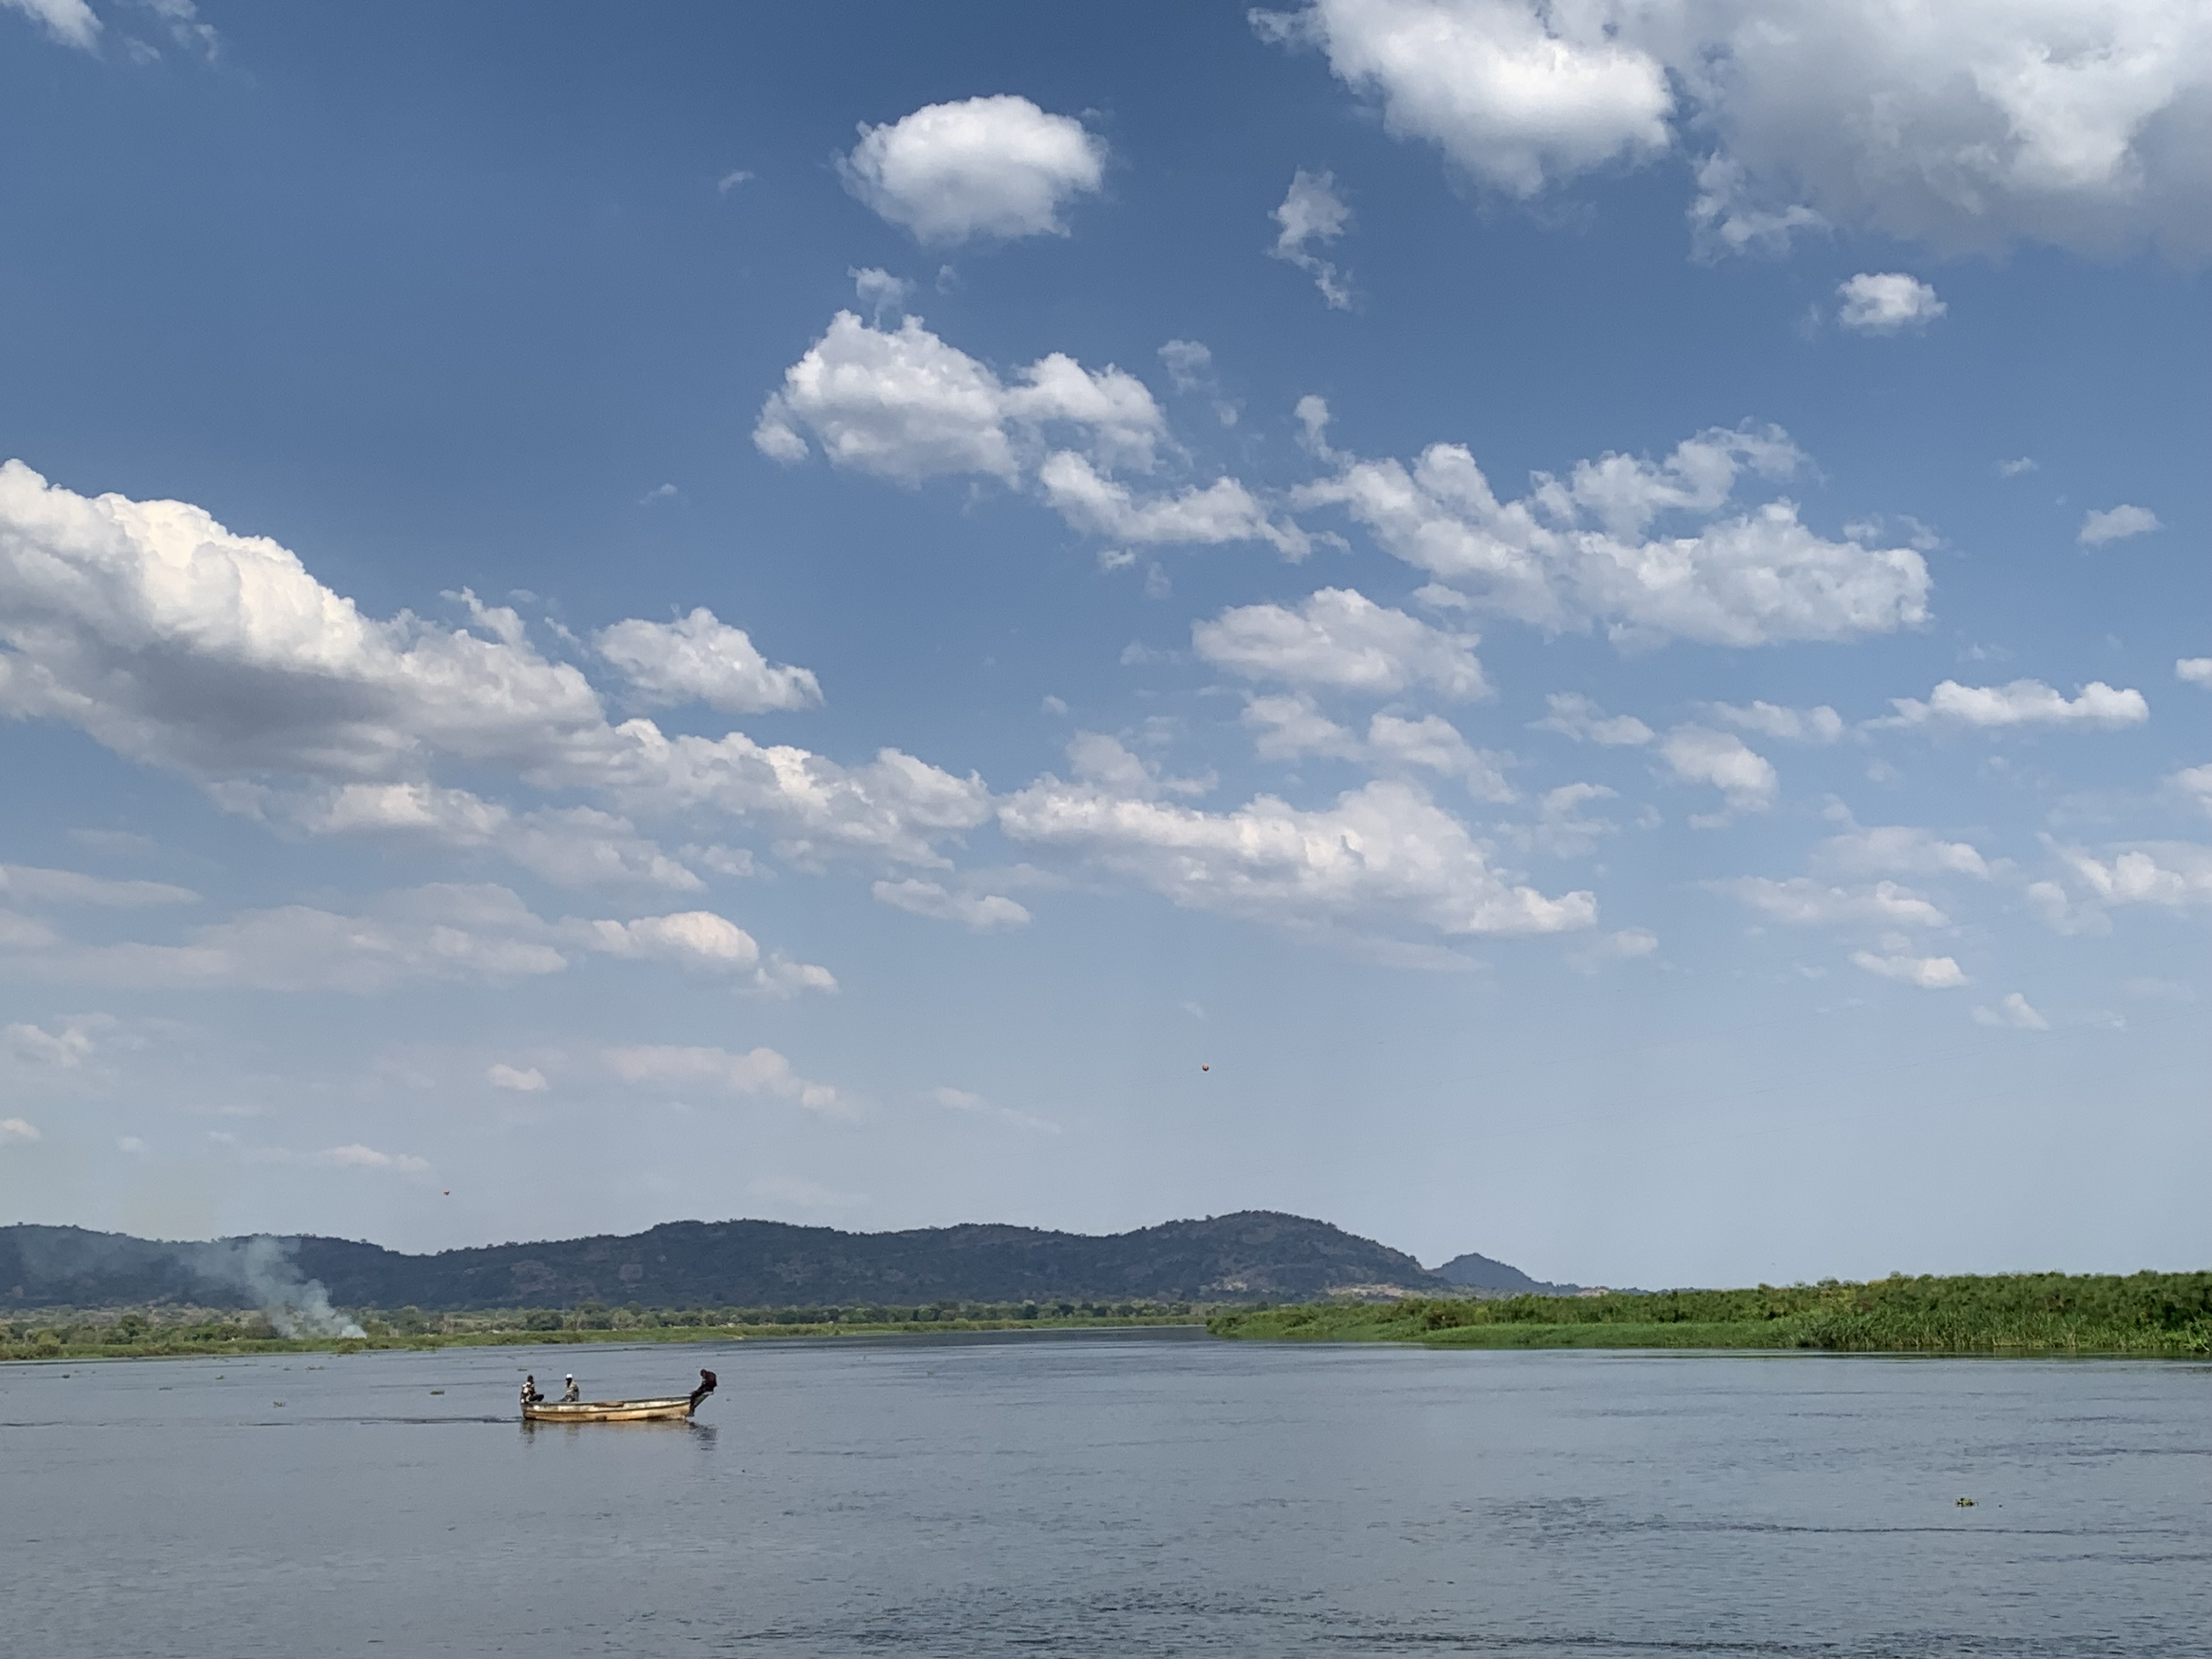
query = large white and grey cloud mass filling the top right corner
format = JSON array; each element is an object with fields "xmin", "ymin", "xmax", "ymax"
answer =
[{"xmin": 1256, "ymin": 0, "xmax": 2212, "ymax": 259}]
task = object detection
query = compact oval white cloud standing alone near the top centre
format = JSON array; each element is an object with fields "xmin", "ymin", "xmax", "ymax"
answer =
[{"xmin": 838, "ymin": 93, "xmax": 1106, "ymax": 246}]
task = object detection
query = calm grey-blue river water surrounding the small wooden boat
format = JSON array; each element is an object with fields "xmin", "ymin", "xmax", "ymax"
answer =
[{"xmin": 0, "ymin": 1331, "xmax": 2212, "ymax": 1659}]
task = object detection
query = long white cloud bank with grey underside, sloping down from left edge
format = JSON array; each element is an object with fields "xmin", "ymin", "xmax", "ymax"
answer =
[{"xmin": 0, "ymin": 455, "xmax": 991, "ymax": 885}]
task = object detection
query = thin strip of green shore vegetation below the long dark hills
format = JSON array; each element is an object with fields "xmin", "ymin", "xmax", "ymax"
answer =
[{"xmin": 0, "ymin": 1301, "xmax": 1203, "ymax": 1361}]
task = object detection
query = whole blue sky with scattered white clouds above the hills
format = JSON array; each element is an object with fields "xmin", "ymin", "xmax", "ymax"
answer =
[{"xmin": 0, "ymin": 0, "xmax": 2212, "ymax": 1283}]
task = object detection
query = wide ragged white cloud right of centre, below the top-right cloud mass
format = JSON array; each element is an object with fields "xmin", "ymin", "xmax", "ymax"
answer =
[{"xmin": 1292, "ymin": 427, "xmax": 1929, "ymax": 646}]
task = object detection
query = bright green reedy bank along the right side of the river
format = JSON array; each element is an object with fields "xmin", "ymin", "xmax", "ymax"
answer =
[{"xmin": 1205, "ymin": 1272, "xmax": 2212, "ymax": 1356}]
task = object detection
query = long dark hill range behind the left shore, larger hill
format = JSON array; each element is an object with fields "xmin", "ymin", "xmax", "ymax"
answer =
[{"xmin": 0, "ymin": 1210, "xmax": 1460, "ymax": 1312}]
